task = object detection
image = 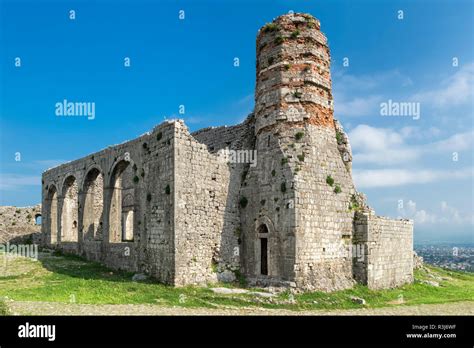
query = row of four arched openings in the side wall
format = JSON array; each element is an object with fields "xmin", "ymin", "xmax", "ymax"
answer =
[{"xmin": 43, "ymin": 160, "xmax": 135, "ymax": 244}]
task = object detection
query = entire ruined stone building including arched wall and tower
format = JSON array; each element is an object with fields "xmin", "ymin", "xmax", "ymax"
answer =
[{"xmin": 39, "ymin": 14, "xmax": 413, "ymax": 291}]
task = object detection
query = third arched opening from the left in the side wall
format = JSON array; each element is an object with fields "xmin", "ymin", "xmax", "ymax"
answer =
[{"xmin": 81, "ymin": 168, "xmax": 104, "ymax": 240}]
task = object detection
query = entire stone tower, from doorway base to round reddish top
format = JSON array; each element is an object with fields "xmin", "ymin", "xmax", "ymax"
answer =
[{"xmin": 240, "ymin": 14, "xmax": 356, "ymax": 291}]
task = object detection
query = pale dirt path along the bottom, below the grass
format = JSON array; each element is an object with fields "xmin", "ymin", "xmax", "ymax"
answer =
[{"xmin": 7, "ymin": 300, "xmax": 474, "ymax": 315}]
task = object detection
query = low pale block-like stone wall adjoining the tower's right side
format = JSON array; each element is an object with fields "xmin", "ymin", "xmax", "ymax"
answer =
[{"xmin": 354, "ymin": 212, "xmax": 413, "ymax": 289}]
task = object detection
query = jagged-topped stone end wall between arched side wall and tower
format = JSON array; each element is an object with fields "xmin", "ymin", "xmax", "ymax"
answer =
[{"xmin": 175, "ymin": 116, "xmax": 253, "ymax": 285}]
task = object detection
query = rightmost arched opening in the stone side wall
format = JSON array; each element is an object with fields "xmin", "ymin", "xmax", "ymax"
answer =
[{"xmin": 109, "ymin": 161, "xmax": 135, "ymax": 243}]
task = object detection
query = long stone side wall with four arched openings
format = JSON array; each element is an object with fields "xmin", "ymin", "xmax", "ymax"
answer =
[{"xmin": 42, "ymin": 122, "xmax": 175, "ymax": 282}]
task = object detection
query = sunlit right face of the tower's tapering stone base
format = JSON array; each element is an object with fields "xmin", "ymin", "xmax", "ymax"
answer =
[{"xmin": 295, "ymin": 125, "xmax": 355, "ymax": 291}]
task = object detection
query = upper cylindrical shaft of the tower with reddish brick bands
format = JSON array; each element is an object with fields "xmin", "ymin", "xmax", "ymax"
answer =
[{"xmin": 255, "ymin": 14, "xmax": 334, "ymax": 135}]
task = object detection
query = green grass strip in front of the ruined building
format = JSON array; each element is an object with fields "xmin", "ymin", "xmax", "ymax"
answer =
[{"xmin": 0, "ymin": 253, "xmax": 474, "ymax": 315}]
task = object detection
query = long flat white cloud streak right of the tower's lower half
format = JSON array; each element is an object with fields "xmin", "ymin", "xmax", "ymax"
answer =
[{"xmin": 353, "ymin": 168, "xmax": 474, "ymax": 188}]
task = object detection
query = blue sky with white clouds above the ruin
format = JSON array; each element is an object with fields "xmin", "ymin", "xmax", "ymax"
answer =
[{"xmin": 0, "ymin": 0, "xmax": 474, "ymax": 242}]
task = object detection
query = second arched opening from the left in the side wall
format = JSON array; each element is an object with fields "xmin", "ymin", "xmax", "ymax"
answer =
[{"xmin": 61, "ymin": 176, "xmax": 78, "ymax": 242}]
